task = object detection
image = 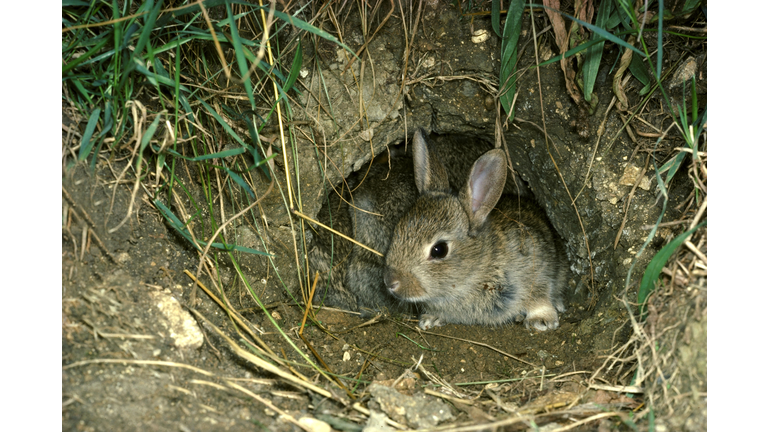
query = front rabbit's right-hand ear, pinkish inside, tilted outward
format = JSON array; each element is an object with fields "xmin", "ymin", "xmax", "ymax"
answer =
[{"xmin": 459, "ymin": 149, "xmax": 507, "ymax": 232}]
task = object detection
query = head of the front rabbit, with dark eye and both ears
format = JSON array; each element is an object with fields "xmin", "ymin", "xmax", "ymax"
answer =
[{"xmin": 384, "ymin": 132, "xmax": 507, "ymax": 303}]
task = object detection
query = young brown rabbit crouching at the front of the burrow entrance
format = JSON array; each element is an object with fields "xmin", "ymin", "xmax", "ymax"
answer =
[{"xmin": 384, "ymin": 140, "xmax": 568, "ymax": 331}]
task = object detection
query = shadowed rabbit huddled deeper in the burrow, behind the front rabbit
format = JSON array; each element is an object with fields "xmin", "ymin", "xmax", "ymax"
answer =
[{"xmin": 309, "ymin": 157, "xmax": 418, "ymax": 316}]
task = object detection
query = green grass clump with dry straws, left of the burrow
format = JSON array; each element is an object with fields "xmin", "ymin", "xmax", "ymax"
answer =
[{"xmin": 62, "ymin": 0, "xmax": 358, "ymax": 398}]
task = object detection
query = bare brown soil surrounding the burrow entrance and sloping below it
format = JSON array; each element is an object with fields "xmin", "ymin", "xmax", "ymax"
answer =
[{"xmin": 62, "ymin": 2, "xmax": 706, "ymax": 431}]
